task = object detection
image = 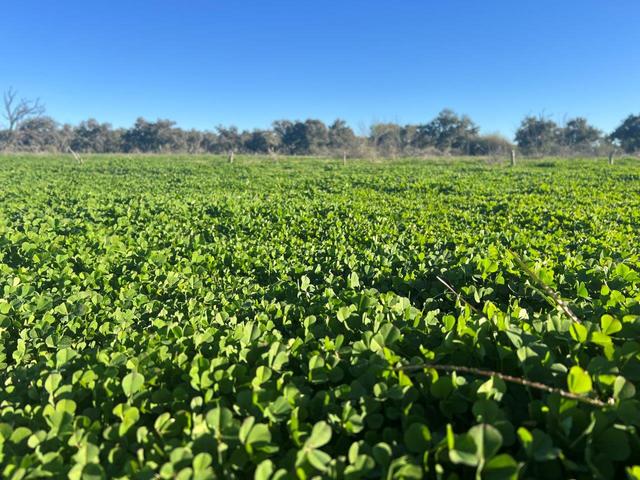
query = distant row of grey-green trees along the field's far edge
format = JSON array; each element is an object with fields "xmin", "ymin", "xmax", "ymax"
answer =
[{"xmin": 0, "ymin": 89, "xmax": 640, "ymax": 157}]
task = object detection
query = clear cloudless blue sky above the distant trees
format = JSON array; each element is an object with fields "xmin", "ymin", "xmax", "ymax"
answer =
[{"xmin": 0, "ymin": 0, "xmax": 640, "ymax": 136}]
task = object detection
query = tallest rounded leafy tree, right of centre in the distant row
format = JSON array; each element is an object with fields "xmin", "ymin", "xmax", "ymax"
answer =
[{"xmin": 416, "ymin": 109, "xmax": 479, "ymax": 154}]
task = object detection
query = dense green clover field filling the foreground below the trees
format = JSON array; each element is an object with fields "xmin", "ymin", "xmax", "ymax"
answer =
[{"xmin": 0, "ymin": 156, "xmax": 640, "ymax": 480}]
